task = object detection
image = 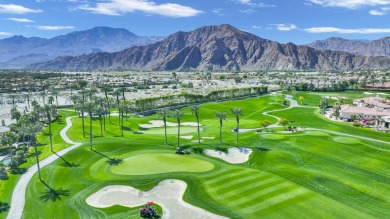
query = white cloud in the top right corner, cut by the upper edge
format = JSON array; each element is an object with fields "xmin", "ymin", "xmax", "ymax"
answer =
[{"xmin": 309, "ymin": 0, "xmax": 390, "ymax": 9}]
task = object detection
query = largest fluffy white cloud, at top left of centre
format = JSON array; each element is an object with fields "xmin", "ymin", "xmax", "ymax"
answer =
[{"xmin": 78, "ymin": 0, "xmax": 202, "ymax": 18}]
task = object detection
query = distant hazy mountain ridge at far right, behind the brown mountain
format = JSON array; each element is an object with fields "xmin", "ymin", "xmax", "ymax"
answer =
[{"xmin": 307, "ymin": 37, "xmax": 390, "ymax": 57}]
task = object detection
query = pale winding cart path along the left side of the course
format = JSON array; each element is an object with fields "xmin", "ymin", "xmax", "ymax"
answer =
[{"xmin": 7, "ymin": 117, "xmax": 81, "ymax": 219}]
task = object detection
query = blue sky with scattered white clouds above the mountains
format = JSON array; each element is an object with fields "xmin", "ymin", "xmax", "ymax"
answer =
[{"xmin": 0, "ymin": 0, "xmax": 390, "ymax": 44}]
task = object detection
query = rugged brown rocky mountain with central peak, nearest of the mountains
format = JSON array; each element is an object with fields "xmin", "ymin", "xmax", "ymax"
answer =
[{"xmin": 29, "ymin": 24, "xmax": 390, "ymax": 70}]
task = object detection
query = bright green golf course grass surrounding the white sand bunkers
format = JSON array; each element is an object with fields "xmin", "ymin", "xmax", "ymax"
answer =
[{"xmin": 0, "ymin": 91, "xmax": 390, "ymax": 219}]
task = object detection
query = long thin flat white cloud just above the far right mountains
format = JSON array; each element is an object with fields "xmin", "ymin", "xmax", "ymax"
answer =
[{"xmin": 304, "ymin": 27, "xmax": 390, "ymax": 34}]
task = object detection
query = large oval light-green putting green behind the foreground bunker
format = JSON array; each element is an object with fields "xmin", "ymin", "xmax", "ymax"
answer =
[{"xmin": 111, "ymin": 153, "xmax": 214, "ymax": 175}]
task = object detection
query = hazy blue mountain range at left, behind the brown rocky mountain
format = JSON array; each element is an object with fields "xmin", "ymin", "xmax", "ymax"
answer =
[{"xmin": 0, "ymin": 27, "xmax": 162, "ymax": 68}]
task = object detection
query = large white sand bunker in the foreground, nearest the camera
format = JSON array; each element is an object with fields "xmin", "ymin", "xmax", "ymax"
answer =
[{"xmin": 86, "ymin": 180, "xmax": 225, "ymax": 219}]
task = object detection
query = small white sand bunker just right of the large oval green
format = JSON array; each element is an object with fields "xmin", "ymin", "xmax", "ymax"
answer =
[{"xmin": 204, "ymin": 148, "xmax": 252, "ymax": 164}]
